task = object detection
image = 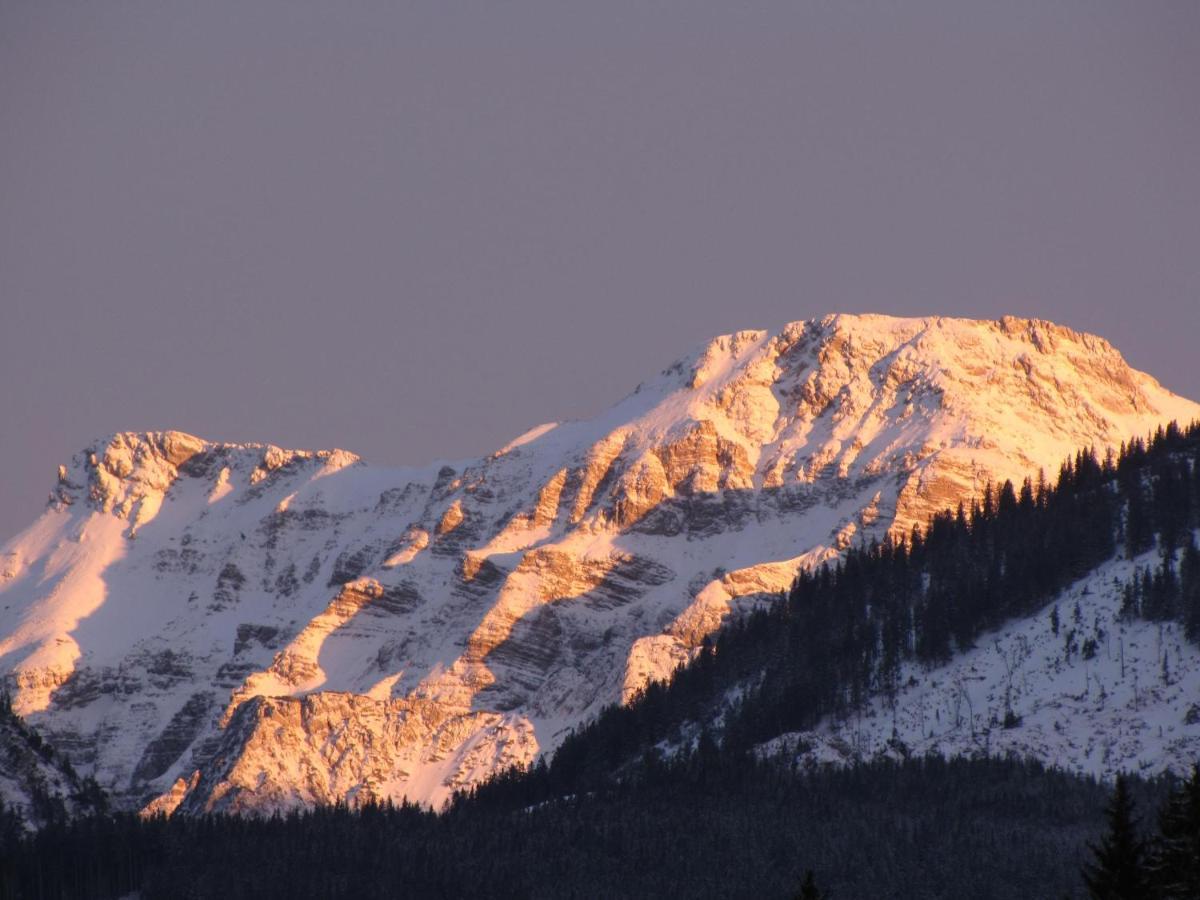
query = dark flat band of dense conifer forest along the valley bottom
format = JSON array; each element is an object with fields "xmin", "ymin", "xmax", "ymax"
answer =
[{"xmin": 0, "ymin": 748, "xmax": 1174, "ymax": 900}]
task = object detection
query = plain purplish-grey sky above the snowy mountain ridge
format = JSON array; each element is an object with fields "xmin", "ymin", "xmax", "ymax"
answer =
[{"xmin": 0, "ymin": 0, "xmax": 1200, "ymax": 539}]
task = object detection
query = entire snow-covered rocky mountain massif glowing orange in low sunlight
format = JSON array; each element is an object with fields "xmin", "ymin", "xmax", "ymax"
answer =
[{"xmin": 0, "ymin": 316, "xmax": 1200, "ymax": 812}]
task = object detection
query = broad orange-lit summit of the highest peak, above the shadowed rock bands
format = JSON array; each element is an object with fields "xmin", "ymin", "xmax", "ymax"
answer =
[{"xmin": 632, "ymin": 314, "xmax": 1198, "ymax": 523}]
